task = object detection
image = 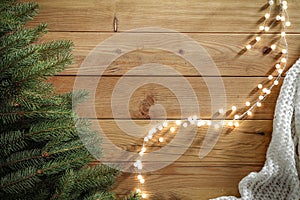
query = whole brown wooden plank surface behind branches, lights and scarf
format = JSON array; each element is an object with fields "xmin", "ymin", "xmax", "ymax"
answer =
[{"xmin": 28, "ymin": 0, "xmax": 300, "ymax": 200}]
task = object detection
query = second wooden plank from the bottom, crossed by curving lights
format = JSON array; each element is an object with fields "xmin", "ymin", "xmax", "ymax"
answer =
[{"xmin": 88, "ymin": 120, "xmax": 272, "ymax": 165}]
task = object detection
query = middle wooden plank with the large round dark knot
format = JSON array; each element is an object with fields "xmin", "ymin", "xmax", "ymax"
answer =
[{"xmin": 50, "ymin": 76, "xmax": 280, "ymax": 119}]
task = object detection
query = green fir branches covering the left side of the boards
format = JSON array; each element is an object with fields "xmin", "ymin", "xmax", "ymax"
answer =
[{"xmin": 0, "ymin": 0, "xmax": 139, "ymax": 200}]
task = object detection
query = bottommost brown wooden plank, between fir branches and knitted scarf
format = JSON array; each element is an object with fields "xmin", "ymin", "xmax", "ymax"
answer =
[{"xmin": 114, "ymin": 172, "xmax": 243, "ymax": 200}]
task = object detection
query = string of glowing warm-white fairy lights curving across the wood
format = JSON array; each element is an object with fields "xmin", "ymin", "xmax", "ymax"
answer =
[{"xmin": 133, "ymin": 0, "xmax": 291, "ymax": 199}]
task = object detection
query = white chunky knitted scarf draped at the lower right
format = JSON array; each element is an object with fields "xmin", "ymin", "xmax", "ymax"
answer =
[{"xmin": 215, "ymin": 59, "xmax": 300, "ymax": 200}]
